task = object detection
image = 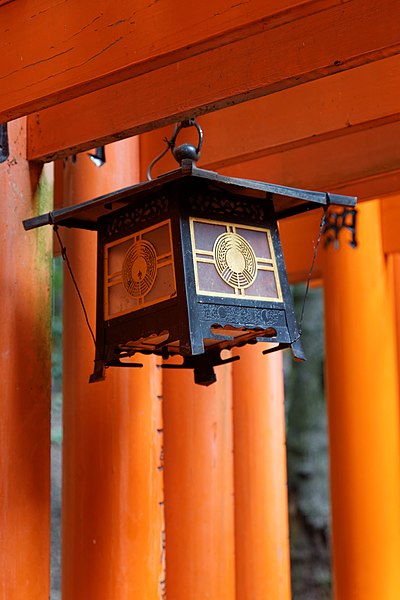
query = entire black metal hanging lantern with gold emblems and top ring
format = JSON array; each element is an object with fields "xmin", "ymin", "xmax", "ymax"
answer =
[{"xmin": 24, "ymin": 121, "xmax": 356, "ymax": 385}]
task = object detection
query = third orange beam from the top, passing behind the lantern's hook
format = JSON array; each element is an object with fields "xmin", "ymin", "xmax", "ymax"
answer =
[{"xmin": 141, "ymin": 56, "xmax": 400, "ymax": 175}]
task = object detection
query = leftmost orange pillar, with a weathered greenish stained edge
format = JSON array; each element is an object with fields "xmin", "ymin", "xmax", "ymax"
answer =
[{"xmin": 0, "ymin": 119, "xmax": 52, "ymax": 600}]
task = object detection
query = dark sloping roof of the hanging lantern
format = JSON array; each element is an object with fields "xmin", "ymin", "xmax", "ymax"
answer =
[{"xmin": 23, "ymin": 160, "xmax": 357, "ymax": 230}]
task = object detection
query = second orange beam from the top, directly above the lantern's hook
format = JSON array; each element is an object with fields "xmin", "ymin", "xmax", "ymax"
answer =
[{"xmin": 29, "ymin": 0, "xmax": 400, "ymax": 161}]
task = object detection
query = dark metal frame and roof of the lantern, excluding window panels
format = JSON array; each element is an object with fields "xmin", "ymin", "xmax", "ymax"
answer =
[{"xmin": 24, "ymin": 159, "xmax": 356, "ymax": 385}]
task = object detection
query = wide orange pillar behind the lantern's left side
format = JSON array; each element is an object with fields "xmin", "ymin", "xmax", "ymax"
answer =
[{"xmin": 60, "ymin": 139, "xmax": 164, "ymax": 600}]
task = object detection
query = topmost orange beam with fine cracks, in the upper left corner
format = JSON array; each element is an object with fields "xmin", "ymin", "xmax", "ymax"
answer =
[{"xmin": 0, "ymin": 0, "xmax": 341, "ymax": 123}]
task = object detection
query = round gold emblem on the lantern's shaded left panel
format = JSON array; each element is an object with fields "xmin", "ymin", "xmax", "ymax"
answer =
[{"xmin": 122, "ymin": 240, "xmax": 157, "ymax": 298}]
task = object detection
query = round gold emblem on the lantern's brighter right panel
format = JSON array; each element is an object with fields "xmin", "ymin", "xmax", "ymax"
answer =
[{"xmin": 213, "ymin": 232, "xmax": 257, "ymax": 289}]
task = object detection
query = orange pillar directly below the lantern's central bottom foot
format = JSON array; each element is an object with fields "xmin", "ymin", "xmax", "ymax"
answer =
[{"xmin": 163, "ymin": 366, "xmax": 236, "ymax": 600}]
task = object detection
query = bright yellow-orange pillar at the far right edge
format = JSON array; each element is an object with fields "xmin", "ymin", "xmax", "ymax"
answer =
[{"xmin": 323, "ymin": 200, "xmax": 400, "ymax": 600}]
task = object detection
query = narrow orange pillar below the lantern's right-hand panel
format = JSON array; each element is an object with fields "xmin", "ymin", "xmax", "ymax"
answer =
[{"xmin": 232, "ymin": 346, "xmax": 291, "ymax": 600}]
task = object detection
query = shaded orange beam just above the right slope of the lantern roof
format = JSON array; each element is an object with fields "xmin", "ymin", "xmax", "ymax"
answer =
[{"xmin": 220, "ymin": 122, "xmax": 400, "ymax": 199}]
